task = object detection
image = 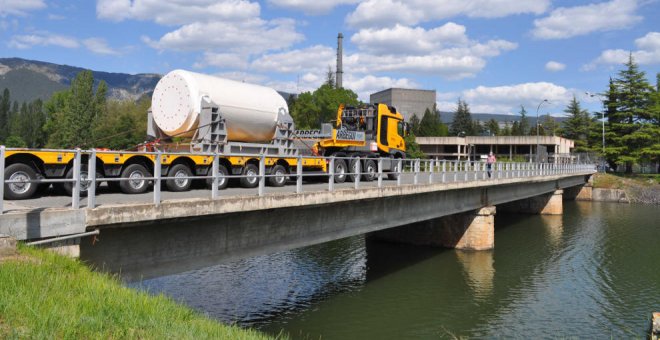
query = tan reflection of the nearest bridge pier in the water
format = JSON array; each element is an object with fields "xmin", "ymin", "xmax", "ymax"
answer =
[{"xmin": 454, "ymin": 250, "xmax": 495, "ymax": 299}]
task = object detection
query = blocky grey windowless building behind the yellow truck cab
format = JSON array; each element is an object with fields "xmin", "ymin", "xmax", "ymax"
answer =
[{"xmin": 369, "ymin": 88, "xmax": 435, "ymax": 121}]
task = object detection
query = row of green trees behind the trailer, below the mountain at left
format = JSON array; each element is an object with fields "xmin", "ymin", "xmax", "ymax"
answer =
[{"xmin": 0, "ymin": 71, "xmax": 151, "ymax": 149}]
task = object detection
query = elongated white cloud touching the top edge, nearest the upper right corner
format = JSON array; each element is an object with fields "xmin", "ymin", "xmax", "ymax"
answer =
[{"xmin": 532, "ymin": 0, "xmax": 642, "ymax": 39}]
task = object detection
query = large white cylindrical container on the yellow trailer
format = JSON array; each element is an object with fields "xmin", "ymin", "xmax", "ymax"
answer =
[{"xmin": 151, "ymin": 70, "xmax": 288, "ymax": 142}]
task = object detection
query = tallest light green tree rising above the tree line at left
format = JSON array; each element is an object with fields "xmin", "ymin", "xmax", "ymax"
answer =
[{"xmin": 46, "ymin": 71, "xmax": 108, "ymax": 148}]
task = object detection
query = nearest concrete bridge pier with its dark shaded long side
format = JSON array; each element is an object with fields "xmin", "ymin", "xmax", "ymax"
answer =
[{"xmin": 372, "ymin": 206, "xmax": 495, "ymax": 250}]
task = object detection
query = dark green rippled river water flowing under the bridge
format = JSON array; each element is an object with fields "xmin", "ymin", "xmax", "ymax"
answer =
[{"xmin": 130, "ymin": 202, "xmax": 660, "ymax": 339}]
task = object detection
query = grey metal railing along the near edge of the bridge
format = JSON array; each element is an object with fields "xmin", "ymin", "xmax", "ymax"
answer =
[{"xmin": 0, "ymin": 146, "xmax": 595, "ymax": 214}]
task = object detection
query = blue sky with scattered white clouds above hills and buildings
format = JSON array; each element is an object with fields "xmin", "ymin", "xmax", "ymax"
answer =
[{"xmin": 0, "ymin": 0, "xmax": 660, "ymax": 116}]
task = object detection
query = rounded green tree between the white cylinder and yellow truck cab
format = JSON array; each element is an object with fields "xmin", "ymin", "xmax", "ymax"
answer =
[{"xmin": 289, "ymin": 84, "xmax": 360, "ymax": 129}]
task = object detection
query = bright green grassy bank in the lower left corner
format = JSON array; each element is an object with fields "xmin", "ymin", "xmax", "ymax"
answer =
[{"xmin": 0, "ymin": 247, "xmax": 268, "ymax": 339}]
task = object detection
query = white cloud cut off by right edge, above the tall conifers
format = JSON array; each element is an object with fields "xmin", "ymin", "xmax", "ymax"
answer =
[{"xmin": 582, "ymin": 32, "xmax": 660, "ymax": 71}]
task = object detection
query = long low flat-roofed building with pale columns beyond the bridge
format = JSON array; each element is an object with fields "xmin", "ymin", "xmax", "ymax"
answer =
[{"xmin": 416, "ymin": 136, "xmax": 575, "ymax": 163}]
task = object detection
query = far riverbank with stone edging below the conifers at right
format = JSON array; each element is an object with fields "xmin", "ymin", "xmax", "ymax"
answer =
[{"xmin": 592, "ymin": 173, "xmax": 660, "ymax": 204}]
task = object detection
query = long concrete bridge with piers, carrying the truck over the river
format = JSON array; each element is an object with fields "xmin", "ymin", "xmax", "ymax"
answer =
[{"xmin": 0, "ymin": 155, "xmax": 595, "ymax": 278}]
